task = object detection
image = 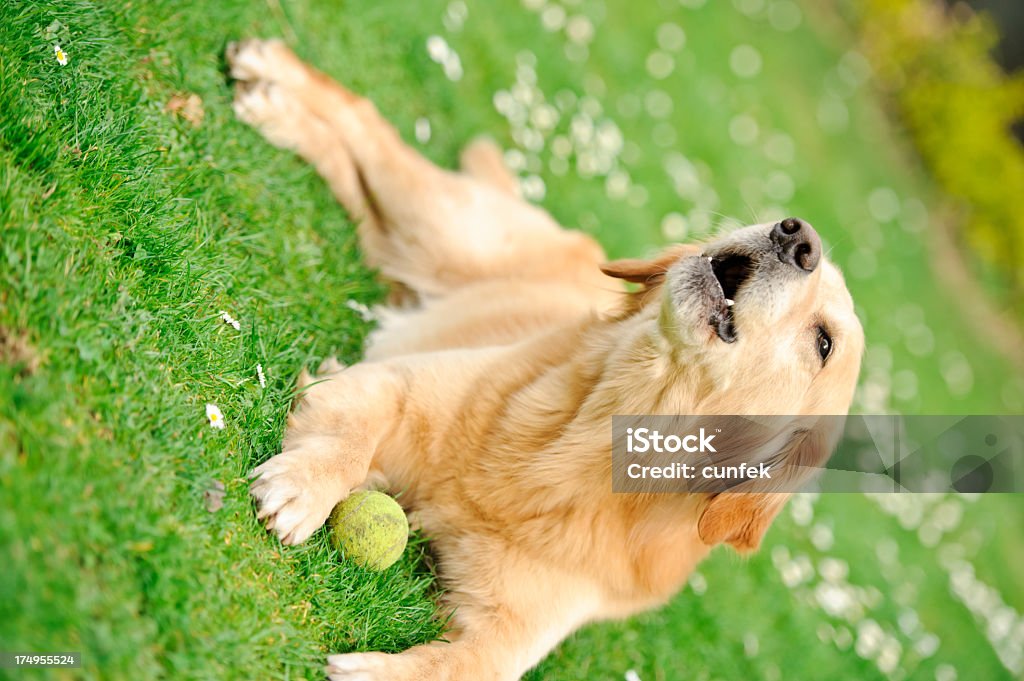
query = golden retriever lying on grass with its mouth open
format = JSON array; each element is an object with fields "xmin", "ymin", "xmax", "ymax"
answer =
[{"xmin": 227, "ymin": 40, "xmax": 863, "ymax": 681}]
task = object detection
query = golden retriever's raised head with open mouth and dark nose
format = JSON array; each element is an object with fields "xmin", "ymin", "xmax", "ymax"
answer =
[{"xmin": 603, "ymin": 218, "xmax": 864, "ymax": 550}]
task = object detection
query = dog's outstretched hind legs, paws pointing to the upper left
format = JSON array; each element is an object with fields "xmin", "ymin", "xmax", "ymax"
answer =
[{"xmin": 227, "ymin": 40, "xmax": 607, "ymax": 295}]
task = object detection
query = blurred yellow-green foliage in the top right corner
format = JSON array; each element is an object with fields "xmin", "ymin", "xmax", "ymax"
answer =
[{"xmin": 858, "ymin": 0, "xmax": 1024, "ymax": 307}]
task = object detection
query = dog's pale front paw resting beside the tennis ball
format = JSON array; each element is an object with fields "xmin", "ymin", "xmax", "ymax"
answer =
[{"xmin": 249, "ymin": 450, "xmax": 347, "ymax": 544}]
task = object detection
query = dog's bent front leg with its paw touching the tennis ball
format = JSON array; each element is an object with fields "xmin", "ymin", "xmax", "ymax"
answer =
[{"xmin": 250, "ymin": 364, "xmax": 407, "ymax": 544}]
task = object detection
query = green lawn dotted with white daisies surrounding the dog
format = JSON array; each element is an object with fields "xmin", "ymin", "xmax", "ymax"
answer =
[{"xmin": 0, "ymin": 0, "xmax": 1024, "ymax": 681}]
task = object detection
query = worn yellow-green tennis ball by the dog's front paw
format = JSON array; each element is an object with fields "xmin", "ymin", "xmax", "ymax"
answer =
[{"xmin": 327, "ymin": 491, "xmax": 409, "ymax": 570}]
